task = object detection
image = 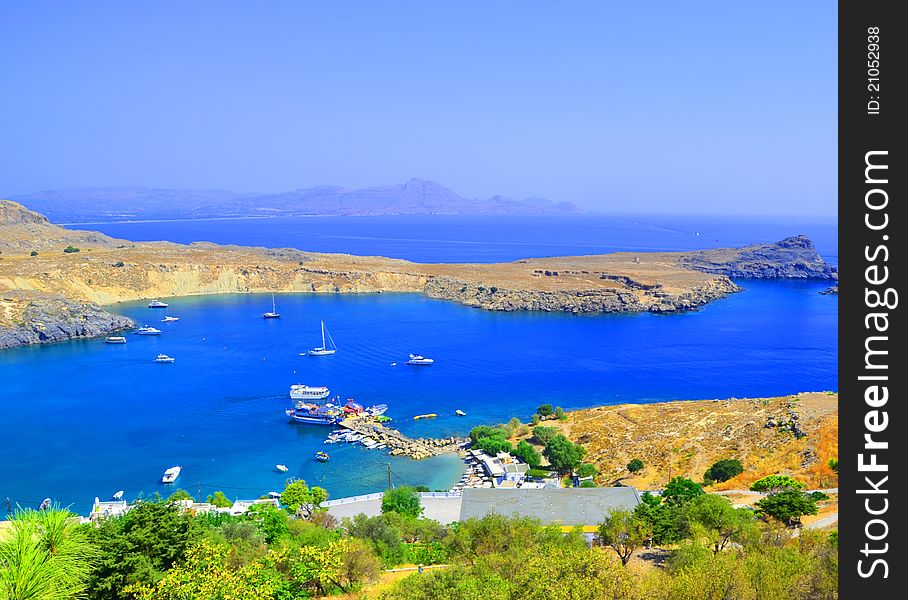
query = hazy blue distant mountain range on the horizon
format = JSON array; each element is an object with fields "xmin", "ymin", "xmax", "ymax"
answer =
[{"xmin": 12, "ymin": 179, "xmax": 580, "ymax": 223}]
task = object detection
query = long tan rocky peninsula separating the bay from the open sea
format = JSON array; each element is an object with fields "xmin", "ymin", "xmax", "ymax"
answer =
[{"xmin": 0, "ymin": 200, "xmax": 837, "ymax": 349}]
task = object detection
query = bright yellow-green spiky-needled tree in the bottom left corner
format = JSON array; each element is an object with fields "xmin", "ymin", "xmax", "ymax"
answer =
[{"xmin": 0, "ymin": 507, "xmax": 98, "ymax": 600}]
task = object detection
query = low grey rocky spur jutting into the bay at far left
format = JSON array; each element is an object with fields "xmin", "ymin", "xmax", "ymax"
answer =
[{"xmin": 0, "ymin": 292, "xmax": 135, "ymax": 350}]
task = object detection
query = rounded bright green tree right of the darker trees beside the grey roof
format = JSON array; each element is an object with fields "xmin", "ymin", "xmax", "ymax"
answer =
[{"xmin": 681, "ymin": 494, "xmax": 754, "ymax": 554}]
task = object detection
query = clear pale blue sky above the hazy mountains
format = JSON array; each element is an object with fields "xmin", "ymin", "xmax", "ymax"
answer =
[{"xmin": 0, "ymin": 1, "xmax": 837, "ymax": 215}]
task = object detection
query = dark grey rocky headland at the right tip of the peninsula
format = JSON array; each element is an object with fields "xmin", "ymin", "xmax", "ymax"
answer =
[{"xmin": 678, "ymin": 235, "xmax": 839, "ymax": 281}]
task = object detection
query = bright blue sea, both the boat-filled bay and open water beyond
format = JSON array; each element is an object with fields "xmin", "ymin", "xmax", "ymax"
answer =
[{"xmin": 0, "ymin": 217, "xmax": 838, "ymax": 513}]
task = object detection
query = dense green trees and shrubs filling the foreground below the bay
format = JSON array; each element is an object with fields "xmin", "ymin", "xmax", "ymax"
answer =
[{"xmin": 0, "ymin": 476, "xmax": 838, "ymax": 600}]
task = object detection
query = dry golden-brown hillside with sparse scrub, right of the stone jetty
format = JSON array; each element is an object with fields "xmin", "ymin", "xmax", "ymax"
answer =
[{"xmin": 543, "ymin": 392, "xmax": 838, "ymax": 489}]
